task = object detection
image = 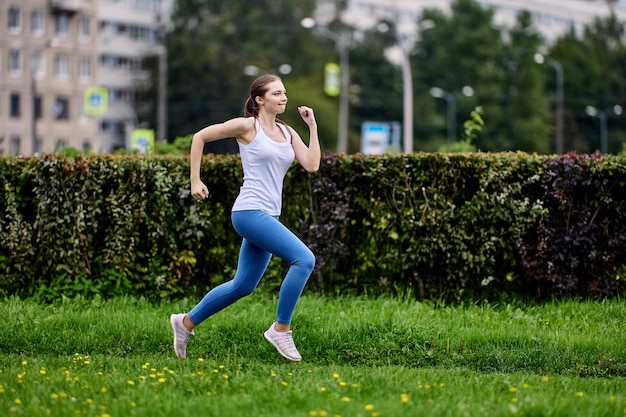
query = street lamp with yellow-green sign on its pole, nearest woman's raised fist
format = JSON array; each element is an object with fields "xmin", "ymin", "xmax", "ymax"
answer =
[{"xmin": 300, "ymin": 17, "xmax": 350, "ymax": 153}]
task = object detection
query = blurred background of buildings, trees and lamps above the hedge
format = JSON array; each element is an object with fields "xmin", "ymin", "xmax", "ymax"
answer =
[{"xmin": 0, "ymin": 0, "xmax": 626, "ymax": 156}]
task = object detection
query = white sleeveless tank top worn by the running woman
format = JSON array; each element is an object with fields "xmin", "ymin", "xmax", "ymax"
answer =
[{"xmin": 233, "ymin": 119, "xmax": 295, "ymax": 216}]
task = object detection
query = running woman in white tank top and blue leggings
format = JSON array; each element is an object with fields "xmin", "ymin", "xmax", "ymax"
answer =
[{"xmin": 170, "ymin": 75, "xmax": 321, "ymax": 361}]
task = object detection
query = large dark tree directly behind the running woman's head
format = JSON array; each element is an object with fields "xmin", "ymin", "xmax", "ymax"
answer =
[{"xmin": 143, "ymin": 0, "xmax": 342, "ymax": 150}]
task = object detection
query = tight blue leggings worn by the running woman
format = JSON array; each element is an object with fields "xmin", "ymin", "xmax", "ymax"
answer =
[{"xmin": 189, "ymin": 210, "xmax": 315, "ymax": 325}]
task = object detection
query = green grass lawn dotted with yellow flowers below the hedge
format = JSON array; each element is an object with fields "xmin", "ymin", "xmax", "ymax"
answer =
[{"xmin": 0, "ymin": 295, "xmax": 626, "ymax": 417}]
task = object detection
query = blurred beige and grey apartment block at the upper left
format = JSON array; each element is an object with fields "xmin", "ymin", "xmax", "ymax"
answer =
[{"xmin": 0, "ymin": 0, "xmax": 169, "ymax": 156}]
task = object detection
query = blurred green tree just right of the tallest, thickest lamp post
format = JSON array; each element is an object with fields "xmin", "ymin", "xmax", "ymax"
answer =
[{"xmin": 412, "ymin": 0, "xmax": 508, "ymax": 150}]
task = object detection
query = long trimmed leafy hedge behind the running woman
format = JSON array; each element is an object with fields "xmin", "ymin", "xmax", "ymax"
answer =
[{"xmin": 0, "ymin": 153, "xmax": 626, "ymax": 302}]
